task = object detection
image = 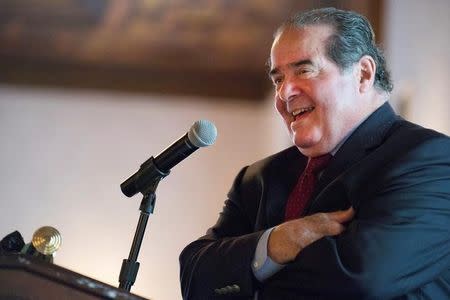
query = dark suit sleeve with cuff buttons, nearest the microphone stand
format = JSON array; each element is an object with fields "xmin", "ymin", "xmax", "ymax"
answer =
[{"xmin": 180, "ymin": 168, "xmax": 263, "ymax": 299}]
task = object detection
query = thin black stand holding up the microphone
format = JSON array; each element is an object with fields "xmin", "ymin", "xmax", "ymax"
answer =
[{"xmin": 119, "ymin": 157, "xmax": 169, "ymax": 292}]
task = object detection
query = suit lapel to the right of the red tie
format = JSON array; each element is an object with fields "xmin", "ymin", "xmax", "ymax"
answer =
[{"xmin": 305, "ymin": 102, "xmax": 399, "ymax": 214}]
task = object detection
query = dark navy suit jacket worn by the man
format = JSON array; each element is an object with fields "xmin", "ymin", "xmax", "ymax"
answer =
[{"xmin": 180, "ymin": 103, "xmax": 450, "ymax": 300}]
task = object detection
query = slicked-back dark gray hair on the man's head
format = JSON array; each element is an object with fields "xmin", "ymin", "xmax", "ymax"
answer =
[{"xmin": 276, "ymin": 7, "xmax": 393, "ymax": 93}]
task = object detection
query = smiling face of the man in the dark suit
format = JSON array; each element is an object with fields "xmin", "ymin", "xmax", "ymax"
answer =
[{"xmin": 270, "ymin": 25, "xmax": 363, "ymax": 157}]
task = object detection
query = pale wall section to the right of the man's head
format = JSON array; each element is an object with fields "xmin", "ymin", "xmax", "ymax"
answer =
[{"xmin": 384, "ymin": 0, "xmax": 450, "ymax": 135}]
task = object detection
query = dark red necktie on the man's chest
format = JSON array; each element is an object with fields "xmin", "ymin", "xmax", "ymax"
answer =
[{"xmin": 284, "ymin": 154, "xmax": 332, "ymax": 221}]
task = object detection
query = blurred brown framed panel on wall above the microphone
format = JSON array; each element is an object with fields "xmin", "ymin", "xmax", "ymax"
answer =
[{"xmin": 0, "ymin": 0, "xmax": 383, "ymax": 100}]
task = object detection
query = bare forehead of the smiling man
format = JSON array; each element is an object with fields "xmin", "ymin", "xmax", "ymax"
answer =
[{"xmin": 270, "ymin": 25, "xmax": 332, "ymax": 69}]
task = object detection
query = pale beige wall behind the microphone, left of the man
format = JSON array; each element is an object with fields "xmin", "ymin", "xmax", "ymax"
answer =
[{"xmin": 0, "ymin": 86, "xmax": 287, "ymax": 300}]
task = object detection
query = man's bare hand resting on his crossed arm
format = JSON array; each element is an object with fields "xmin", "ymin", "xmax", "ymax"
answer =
[{"xmin": 267, "ymin": 207, "xmax": 355, "ymax": 264}]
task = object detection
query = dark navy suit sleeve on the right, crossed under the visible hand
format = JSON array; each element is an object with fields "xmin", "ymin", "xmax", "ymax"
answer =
[{"xmin": 267, "ymin": 137, "xmax": 450, "ymax": 299}]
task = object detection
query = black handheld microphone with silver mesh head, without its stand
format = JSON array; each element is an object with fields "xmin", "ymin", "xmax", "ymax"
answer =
[{"xmin": 120, "ymin": 120, "xmax": 217, "ymax": 197}]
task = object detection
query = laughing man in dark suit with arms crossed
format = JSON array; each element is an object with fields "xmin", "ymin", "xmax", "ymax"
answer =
[{"xmin": 180, "ymin": 8, "xmax": 450, "ymax": 299}]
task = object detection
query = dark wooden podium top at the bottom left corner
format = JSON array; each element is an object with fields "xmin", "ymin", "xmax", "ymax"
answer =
[{"xmin": 0, "ymin": 254, "xmax": 146, "ymax": 300}]
